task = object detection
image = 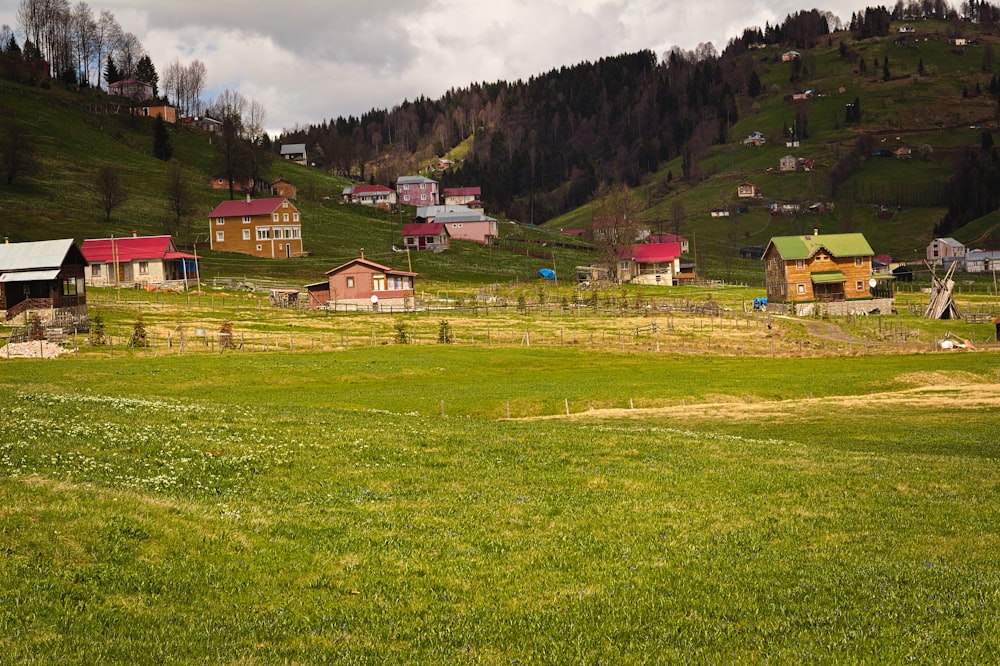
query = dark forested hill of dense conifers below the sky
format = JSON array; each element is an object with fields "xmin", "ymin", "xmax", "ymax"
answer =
[{"xmin": 279, "ymin": 10, "xmax": 852, "ymax": 222}]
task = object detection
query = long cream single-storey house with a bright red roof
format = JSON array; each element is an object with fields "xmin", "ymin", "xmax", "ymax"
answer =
[{"xmin": 80, "ymin": 235, "xmax": 197, "ymax": 287}]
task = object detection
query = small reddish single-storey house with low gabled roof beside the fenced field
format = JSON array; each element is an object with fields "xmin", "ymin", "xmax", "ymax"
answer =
[{"xmin": 306, "ymin": 252, "xmax": 417, "ymax": 310}]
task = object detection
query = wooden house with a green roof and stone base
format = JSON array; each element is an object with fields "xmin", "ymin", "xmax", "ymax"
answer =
[{"xmin": 762, "ymin": 232, "xmax": 891, "ymax": 303}]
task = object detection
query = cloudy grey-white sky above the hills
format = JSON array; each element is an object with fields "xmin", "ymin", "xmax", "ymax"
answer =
[{"xmin": 0, "ymin": 0, "xmax": 870, "ymax": 132}]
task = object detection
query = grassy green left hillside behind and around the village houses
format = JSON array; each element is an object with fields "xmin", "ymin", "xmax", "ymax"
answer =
[{"xmin": 0, "ymin": 82, "xmax": 589, "ymax": 284}]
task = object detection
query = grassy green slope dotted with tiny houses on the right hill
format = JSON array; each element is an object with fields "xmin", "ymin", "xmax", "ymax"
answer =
[{"xmin": 547, "ymin": 21, "xmax": 997, "ymax": 260}]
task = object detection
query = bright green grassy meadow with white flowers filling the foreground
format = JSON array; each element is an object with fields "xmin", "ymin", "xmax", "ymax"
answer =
[{"xmin": 0, "ymin": 332, "xmax": 1000, "ymax": 664}]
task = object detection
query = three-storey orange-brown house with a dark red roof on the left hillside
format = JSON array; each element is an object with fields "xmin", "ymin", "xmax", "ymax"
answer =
[{"xmin": 208, "ymin": 194, "xmax": 305, "ymax": 259}]
